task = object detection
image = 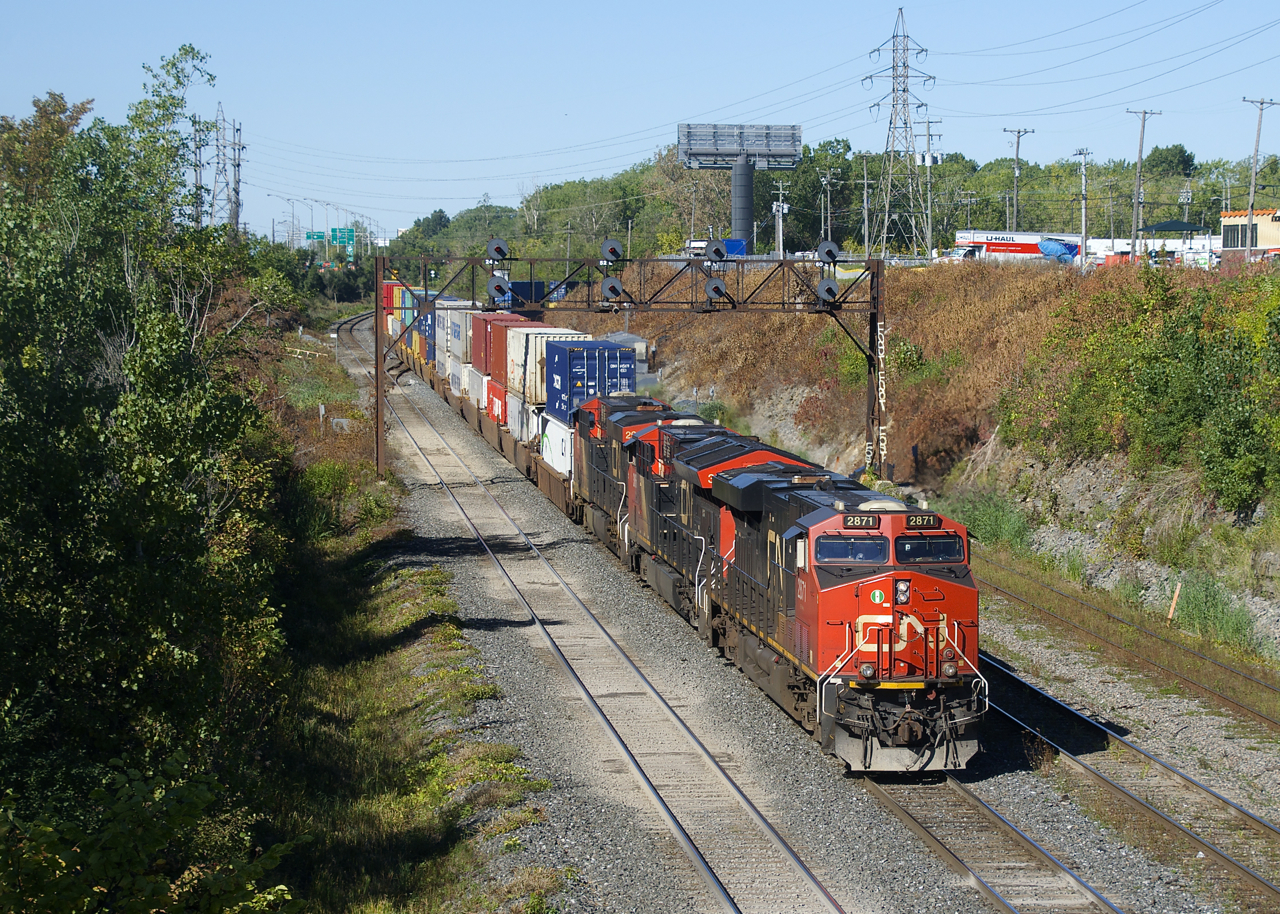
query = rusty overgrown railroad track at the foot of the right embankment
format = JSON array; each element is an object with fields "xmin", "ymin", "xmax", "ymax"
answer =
[{"xmin": 974, "ymin": 550, "xmax": 1280, "ymax": 730}]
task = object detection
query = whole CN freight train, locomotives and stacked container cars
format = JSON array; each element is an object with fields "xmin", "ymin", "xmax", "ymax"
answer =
[{"xmin": 384, "ymin": 281, "xmax": 987, "ymax": 772}]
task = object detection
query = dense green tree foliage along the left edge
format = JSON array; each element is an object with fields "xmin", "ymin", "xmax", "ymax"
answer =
[{"xmin": 0, "ymin": 46, "xmax": 300, "ymax": 910}]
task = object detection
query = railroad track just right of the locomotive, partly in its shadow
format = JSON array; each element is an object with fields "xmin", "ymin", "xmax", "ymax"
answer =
[{"xmin": 983, "ymin": 652, "xmax": 1280, "ymax": 911}]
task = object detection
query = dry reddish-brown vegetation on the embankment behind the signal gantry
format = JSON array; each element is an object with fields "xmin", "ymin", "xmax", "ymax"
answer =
[{"xmin": 552, "ymin": 256, "xmax": 1216, "ymax": 483}]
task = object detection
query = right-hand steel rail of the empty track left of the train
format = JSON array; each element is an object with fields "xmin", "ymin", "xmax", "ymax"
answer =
[{"xmin": 340, "ymin": 311, "xmax": 844, "ymax": 914}]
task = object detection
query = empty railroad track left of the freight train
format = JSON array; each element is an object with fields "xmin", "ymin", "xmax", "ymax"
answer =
[{"xmin": 338, "ymin": 315, "xmax": 842, "ymax": 914}]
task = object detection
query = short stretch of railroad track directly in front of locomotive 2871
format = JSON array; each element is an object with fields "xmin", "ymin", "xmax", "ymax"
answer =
[{"xmin": 863, "ymin": 774, "xmax": 1121, "ymax": 914}]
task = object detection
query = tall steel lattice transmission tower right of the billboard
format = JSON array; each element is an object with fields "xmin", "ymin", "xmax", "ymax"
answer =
[{"xmin": 863, "ymin": 9, "xmax": 933, "ymax": 257}]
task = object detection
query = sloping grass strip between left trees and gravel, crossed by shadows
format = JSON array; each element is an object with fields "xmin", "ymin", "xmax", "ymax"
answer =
[{"xmin": 261, "ymin": 337, "xmax": 571, "ymax": 914}]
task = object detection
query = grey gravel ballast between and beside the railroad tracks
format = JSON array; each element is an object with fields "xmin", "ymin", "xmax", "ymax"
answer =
[{"xmin": 337, "ymin": 327, "xmax": 1274, "ymax": 914}]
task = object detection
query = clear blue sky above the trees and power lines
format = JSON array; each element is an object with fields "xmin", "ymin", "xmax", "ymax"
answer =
[{"xmin": 0, "ymin": 0, "xmax": 1280, "ymax": 234}]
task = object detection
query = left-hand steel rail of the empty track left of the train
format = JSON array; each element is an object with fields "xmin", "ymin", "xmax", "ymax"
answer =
[{"xmin": 337, "ymin": 315, "xmax": 742, "ymax": 914}]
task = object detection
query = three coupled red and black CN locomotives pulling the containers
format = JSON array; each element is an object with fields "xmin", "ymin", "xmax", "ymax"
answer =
[{"xmin": 568, "ymin": 396, "xmax": 986, "ymax": 771}]
